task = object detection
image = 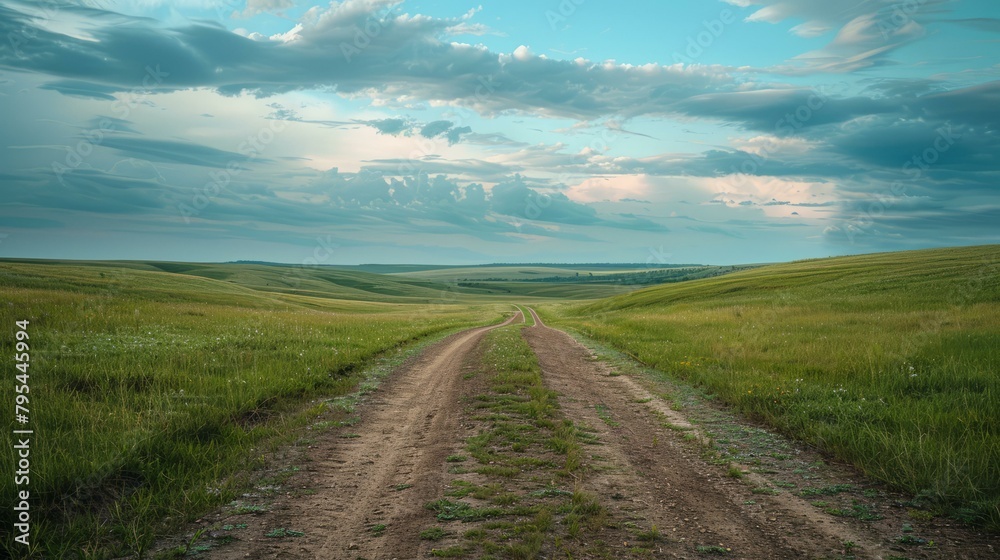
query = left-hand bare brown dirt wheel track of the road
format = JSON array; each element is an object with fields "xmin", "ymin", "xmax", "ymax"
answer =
[{"xmin": 205, "ymin": 313, "xmax": 523, "ymax": 560}]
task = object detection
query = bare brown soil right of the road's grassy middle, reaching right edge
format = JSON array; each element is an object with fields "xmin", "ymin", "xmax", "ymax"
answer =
[{"xmin": 524, "ymin": 310, "xmax": 997, "ymax": 559}]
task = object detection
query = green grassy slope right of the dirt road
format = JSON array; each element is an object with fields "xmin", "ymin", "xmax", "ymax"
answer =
[{"xmin": 538, "ymin": 246, "xmax": 1000, "ymax": 528}]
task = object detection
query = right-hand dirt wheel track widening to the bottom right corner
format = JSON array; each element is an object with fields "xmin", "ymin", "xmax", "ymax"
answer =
[{"xmin": 524, "ymin": 308, "xmax": 994, "ymax": 560}]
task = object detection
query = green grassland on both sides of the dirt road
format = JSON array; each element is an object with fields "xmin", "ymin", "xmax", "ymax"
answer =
[{"xmin": 0, "ymin": 246, "xmax": 1000, "ymax": 558}]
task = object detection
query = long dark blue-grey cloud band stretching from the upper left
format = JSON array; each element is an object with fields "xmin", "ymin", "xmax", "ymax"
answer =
[{"xmin": 0, "ymin": 1, "xmax": 732, "ymax": 117}]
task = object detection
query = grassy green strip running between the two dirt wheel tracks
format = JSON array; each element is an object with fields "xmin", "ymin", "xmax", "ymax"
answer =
[{"xmin": 420, "ymin": 325, "xmax": 659, "ymax": 559}]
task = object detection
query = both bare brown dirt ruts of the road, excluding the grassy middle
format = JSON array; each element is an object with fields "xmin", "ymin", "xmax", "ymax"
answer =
[{"xmin": 191, "ymin": 310, "xmax": 995, "ymax": 560}]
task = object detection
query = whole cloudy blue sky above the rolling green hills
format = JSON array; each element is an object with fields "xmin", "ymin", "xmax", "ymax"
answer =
[{"xmin": 0, "ymin": 0, "xmax": 1000, "ymax": 265}]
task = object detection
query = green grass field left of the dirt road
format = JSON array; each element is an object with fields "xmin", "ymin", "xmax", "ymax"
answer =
[{"xmin": 0, "ymin": 263, "xmax": 500, "ymax": 558}]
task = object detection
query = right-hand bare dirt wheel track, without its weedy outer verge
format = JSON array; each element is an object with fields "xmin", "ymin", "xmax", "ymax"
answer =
[{"xmin": 524, "ymin": 310, "xmax": 839, "ymax": 559}]
